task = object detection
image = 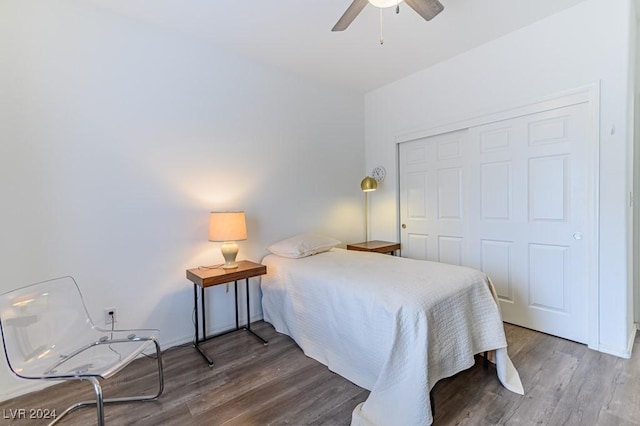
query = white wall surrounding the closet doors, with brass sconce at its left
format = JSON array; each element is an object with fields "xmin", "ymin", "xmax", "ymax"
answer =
[{"xmin": 365, "ymin": 0, "xmax": 634, "ymax": 356}]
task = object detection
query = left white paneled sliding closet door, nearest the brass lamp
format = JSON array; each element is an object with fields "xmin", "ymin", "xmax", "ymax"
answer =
[{"xmin": 400, "ymin": 130, "xmax": 470, "ymax": 265}]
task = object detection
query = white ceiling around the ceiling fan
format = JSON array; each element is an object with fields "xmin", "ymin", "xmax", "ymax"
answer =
[{"xmin": 83, "ymin": 0, "xmax": 584, "ymax": 91}]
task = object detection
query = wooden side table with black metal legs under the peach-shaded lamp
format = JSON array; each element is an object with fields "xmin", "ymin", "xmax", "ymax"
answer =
[{"xmin": 187, "ymin": 260, "xmax": 269, "ymax": 367}]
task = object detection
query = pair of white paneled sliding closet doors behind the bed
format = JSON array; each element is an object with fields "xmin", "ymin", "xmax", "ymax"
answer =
[{"xmin": 400, "ymin": 104, "xmax": 591, "ymax": 342}]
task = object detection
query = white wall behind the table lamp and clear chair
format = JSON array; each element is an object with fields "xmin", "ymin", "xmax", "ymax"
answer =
[{"xmin": 0, "ymin": 0, "xmax": 364, "ymax": 399}]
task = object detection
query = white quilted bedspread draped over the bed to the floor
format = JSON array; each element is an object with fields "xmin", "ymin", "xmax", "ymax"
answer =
[{"xmin": 261, "ymin": 249, "xmax": 523, "ymax": 426}]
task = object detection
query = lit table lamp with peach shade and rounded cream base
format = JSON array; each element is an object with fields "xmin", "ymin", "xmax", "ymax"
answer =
[{"xmin": 209, "ymin": 212, "xmax": 247, "ymax": 269}]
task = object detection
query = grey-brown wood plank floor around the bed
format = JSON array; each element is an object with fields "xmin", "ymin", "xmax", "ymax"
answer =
[{"xmin": 0, "ymin": 322, "xmax": 640, "ymax": 426}]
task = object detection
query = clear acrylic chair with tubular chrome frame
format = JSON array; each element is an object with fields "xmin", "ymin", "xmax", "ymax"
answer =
[{"xmin": 0, "ymin": 277, "xmax": 164, "ymax": 426}]
